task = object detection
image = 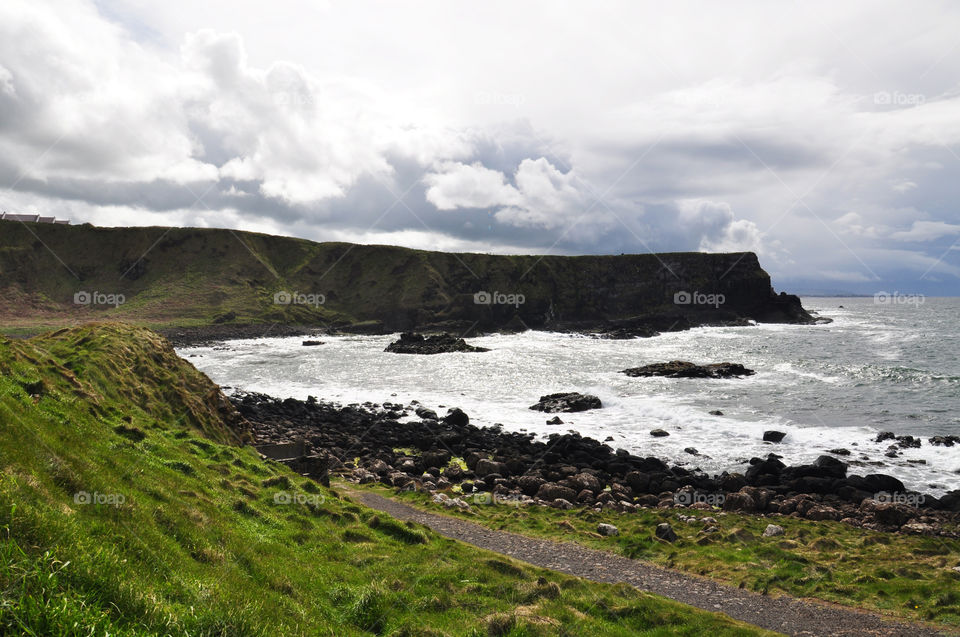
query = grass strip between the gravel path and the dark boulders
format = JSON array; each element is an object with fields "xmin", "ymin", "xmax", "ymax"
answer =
[{"xmin": 365, "ymin": 485, "xmax": 960, "ymax": 626}]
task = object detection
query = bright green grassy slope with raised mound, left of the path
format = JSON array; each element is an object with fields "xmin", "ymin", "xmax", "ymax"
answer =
[{"xmin": 0, "ymin": 324, "xmax": 772, "ymax": 636}]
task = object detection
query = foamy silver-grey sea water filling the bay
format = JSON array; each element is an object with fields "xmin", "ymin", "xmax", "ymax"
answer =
[{"xmin": 179, "ymin": 298, "xmax": 960, "ymax": 494}]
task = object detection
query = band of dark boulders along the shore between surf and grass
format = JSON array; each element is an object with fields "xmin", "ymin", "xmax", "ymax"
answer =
[{"xmin": 231, "ymin": 392, "xmax": 960, "ymax": 537}]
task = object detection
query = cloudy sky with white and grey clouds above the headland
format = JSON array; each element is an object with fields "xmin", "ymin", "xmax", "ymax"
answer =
[{"xmin": 0, "ymin": 0, "xmax": 960, "ymax": 295}]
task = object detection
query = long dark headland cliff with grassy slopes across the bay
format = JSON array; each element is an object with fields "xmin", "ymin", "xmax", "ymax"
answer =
[{"xmin": 0, "ymin": 222, "xmax": 812, "ymax": 333}]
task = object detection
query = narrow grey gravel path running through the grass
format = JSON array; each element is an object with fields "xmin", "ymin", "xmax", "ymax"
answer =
[{"xmin": 343, "ymin": 489, "xmax": 960, "ymax": 637}]
